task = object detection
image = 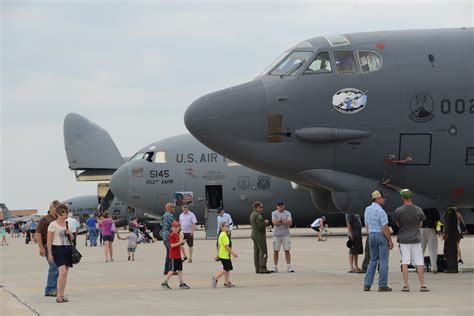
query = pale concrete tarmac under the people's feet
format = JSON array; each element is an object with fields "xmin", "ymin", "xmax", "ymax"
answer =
[{"xmin": 0, "ymin": 228, "xmax": 474, "ymax": 316}]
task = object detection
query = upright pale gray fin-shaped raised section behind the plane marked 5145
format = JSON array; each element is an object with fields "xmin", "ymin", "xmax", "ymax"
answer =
[{"xmin": 63, "ymin": 113, "xmax": 125, "ymax": 181}]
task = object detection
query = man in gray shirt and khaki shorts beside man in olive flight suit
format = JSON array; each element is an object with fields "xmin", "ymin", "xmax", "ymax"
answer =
[{"xmin": 272, "ymin": 201, "xmax": 295, "ymax": 272}]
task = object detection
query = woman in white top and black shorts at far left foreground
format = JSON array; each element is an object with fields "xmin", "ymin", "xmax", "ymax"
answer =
[{"xmin": 47, "ymin": 204, "xmax": 74, "ymax": 303}]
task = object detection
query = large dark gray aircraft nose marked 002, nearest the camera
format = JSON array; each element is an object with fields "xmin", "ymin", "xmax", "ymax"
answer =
[{"xmin": 184, "ymin": 28, "xmax": 474, "ymax": 212}]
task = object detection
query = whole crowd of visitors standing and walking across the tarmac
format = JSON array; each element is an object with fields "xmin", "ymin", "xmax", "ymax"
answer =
[{"xmin": 1, "ymin": 189, "xmax": 467, "ymax": 303}]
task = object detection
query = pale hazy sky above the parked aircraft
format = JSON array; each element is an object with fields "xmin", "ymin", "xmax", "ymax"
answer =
[{"xmin": 0, "ymin": 0, "xmax": 474, "ymax": 213}]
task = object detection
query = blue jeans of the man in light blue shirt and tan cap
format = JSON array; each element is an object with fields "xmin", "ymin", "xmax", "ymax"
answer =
[{"xmin": 364, "ymin": 233, "xmax": 390, "ymax": 287}]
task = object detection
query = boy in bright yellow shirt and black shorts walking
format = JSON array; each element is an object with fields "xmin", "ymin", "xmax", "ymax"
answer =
[{"xmin": 211, "ymin": 223, "xmax": 238, "ymax": 288}]
